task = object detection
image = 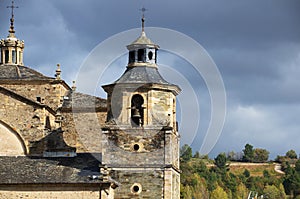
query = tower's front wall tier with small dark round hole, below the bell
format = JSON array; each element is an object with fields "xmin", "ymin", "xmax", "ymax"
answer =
[{"xmin": 102, "ymin": 128, "xmax": 165, "ymax": 168}]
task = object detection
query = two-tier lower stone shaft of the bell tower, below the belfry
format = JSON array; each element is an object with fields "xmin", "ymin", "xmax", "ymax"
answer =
[{"xmin": 102, "ymin": 125, "xmax": 180, "ymax": 199}]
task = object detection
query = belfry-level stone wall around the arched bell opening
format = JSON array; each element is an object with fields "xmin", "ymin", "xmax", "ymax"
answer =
[{"xmin": 108, "ymin": 88, "xmax": 176, "ymax": 128}]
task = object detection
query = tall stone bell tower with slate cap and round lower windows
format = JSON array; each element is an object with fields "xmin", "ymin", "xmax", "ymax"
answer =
[{"xmin": 102, "ymin": 12, "xmax": 180, "ymax": 199}]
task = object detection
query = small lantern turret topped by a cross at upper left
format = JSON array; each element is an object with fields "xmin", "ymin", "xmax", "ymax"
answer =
[{"xmin": 0, "ymin": 1, "xmax": 24, "ymax": 65}]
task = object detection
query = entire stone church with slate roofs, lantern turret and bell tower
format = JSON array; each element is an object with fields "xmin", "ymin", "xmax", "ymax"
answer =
[{"xmin": 0, "ymin": 1, "xmax": 180, "ymax": 199}]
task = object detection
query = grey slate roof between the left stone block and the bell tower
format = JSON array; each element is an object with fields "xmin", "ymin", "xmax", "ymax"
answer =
[{"xmin": 62, "ymin": 91, "xmax": 106, "ymax": 110}]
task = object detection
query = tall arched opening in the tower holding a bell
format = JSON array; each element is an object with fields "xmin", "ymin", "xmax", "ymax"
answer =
[{"xmin": 131, "ymin": 94, "xmax": 144, "ymax": 127}]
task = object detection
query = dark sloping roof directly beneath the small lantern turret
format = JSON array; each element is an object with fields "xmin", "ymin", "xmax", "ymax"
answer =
[{"xmin": 0, "ymin": 64, "xmax": 54, "ymax": 80}]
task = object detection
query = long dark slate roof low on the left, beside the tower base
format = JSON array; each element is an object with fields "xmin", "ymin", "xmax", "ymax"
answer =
[{"xmin": 0, "ymin": 153, "xmax": 102, "ymax": 184}]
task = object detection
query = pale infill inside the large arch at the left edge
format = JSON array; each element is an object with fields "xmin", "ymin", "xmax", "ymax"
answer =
[{"xmin": 0, "ymin": 120, "xmax": 27, "ymax": 156}]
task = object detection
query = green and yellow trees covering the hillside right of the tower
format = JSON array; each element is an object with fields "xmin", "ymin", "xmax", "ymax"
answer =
[{"xmin": 180, "ymin": 144, "xmax": 300, "ymax": 199}]
